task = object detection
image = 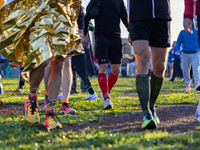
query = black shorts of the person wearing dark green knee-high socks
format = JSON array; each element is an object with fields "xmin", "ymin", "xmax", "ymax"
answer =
[{"xmin": 129, "ymin": 19, "xmax": 170, "ymax": 48}]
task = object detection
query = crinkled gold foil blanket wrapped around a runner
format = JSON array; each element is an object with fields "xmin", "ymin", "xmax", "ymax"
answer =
[{"xmin": 0, "ymin": 0, "xmax": 84, "ymax": 72}]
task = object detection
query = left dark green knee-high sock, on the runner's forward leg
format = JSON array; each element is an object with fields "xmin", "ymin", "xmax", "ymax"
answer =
[{"xmin": 136, "ymin": 75, "xmax": 150, "ymax": 116}]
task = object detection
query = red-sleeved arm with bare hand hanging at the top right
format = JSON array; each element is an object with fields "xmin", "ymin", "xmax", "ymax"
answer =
[{"xmin": 183, "ymin": 0, "xmax": 194, "ymax": 33}]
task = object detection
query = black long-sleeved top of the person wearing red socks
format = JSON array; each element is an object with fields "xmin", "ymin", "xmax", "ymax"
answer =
[{"xmin": 84, "ymin": 0, "xmax": 128, "ymax": 38}]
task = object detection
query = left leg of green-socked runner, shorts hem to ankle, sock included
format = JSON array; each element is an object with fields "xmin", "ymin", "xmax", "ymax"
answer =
[{"xmin": 132, "ymin": 40, "xmax": 150, "ymax": 116}]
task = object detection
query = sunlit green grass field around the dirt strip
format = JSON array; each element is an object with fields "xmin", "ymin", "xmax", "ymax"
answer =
[{"xmin": 0, "ymin": 78, "xmax": 200, "ymax": 150}]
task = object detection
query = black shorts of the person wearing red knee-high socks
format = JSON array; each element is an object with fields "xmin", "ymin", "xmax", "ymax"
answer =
[{"xmin": 95, "ymin": 37, "xmax": 122, "ymax": 64}]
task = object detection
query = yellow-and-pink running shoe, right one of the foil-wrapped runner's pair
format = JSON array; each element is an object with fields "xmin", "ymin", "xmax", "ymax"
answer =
[{"xmin": 43, "ymin": 113, "xmax": 62, "ymax": 129}]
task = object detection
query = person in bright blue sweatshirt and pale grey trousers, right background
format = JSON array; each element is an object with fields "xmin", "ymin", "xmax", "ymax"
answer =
[{"xmin": 175, "ymin": 23, "xmax": 199, "ymax": 91}]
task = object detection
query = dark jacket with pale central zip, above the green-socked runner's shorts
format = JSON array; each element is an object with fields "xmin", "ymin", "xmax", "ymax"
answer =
[{"xmin": 129, "ymin": 0, "xmax": 171, "ymax": 22}]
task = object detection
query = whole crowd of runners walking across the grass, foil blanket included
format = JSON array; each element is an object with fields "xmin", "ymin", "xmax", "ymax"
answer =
[{"xmin": 0, "ymin": 0, "xmax": 200, "ymax": 129}]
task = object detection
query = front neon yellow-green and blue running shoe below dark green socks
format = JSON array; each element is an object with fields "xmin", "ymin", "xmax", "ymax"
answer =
[{"xmin": 141, "ymin": 113, "xmax": 157, "ymax": 129}]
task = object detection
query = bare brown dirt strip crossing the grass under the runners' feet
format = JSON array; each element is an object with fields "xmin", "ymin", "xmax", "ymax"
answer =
[{"xmin": 0, "ymin": 105, "xmax": 200, "ymax": 133}]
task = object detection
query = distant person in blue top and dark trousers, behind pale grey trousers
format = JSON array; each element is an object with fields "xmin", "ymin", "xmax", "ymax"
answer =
[{"xmin": 169, "ymin": 41, "xmax": 183, "ymax": 82}]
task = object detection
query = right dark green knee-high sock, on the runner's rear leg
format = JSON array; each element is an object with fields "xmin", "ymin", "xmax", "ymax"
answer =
[{"xmin": 150, "ymin": 73, "xmax": 164, "ymax": 109}]
